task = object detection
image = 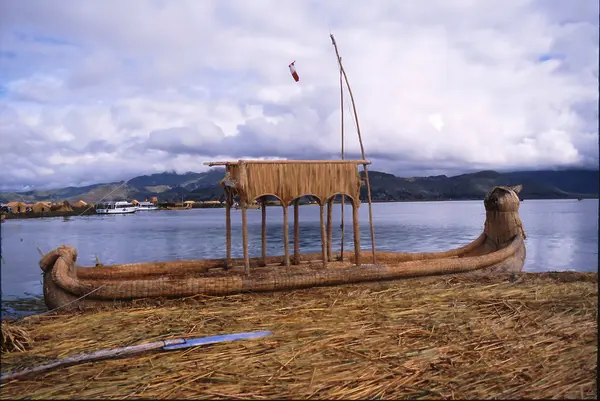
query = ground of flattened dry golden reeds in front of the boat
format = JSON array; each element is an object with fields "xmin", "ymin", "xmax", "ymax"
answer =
[{"xmin": 0, "ymin": 272, "xmax": 598, "ymax": 399}]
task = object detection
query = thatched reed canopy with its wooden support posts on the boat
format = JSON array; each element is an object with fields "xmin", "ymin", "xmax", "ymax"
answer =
[{"xmin": 205, "ymin": 160, "xmax": 371, "ymax": 269}]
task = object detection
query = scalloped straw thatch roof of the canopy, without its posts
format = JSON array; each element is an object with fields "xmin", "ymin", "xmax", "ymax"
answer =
[{"xmin": 205, "ymin": 160, "xmax": 371, "ymax": 204}]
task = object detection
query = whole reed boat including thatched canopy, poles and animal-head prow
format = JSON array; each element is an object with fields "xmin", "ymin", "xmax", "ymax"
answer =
[{"xmin": 40, "ymin": 35, "xmax": 525, "ymax": 310}]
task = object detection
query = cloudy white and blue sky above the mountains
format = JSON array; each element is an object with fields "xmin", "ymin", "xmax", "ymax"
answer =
[{"xmin": 0, "ymin": 0, "xmax": 599, "ymax": 189}]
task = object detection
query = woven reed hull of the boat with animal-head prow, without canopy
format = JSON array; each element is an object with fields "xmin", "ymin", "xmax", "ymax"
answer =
[{"xmin": 40, "ymin": 186, "xmax": 526, "ymax": 310}]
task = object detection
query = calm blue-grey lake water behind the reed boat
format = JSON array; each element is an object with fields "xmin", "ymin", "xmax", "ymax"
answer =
[{"xmin": 0, "ymin": 199, "xmax": 598, "ymax": 314}]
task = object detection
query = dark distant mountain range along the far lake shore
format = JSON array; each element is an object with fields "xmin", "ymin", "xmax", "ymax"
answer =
[{"xmin": 0, "ymin": 168, "xmax": 600, "ymax": 203}]
